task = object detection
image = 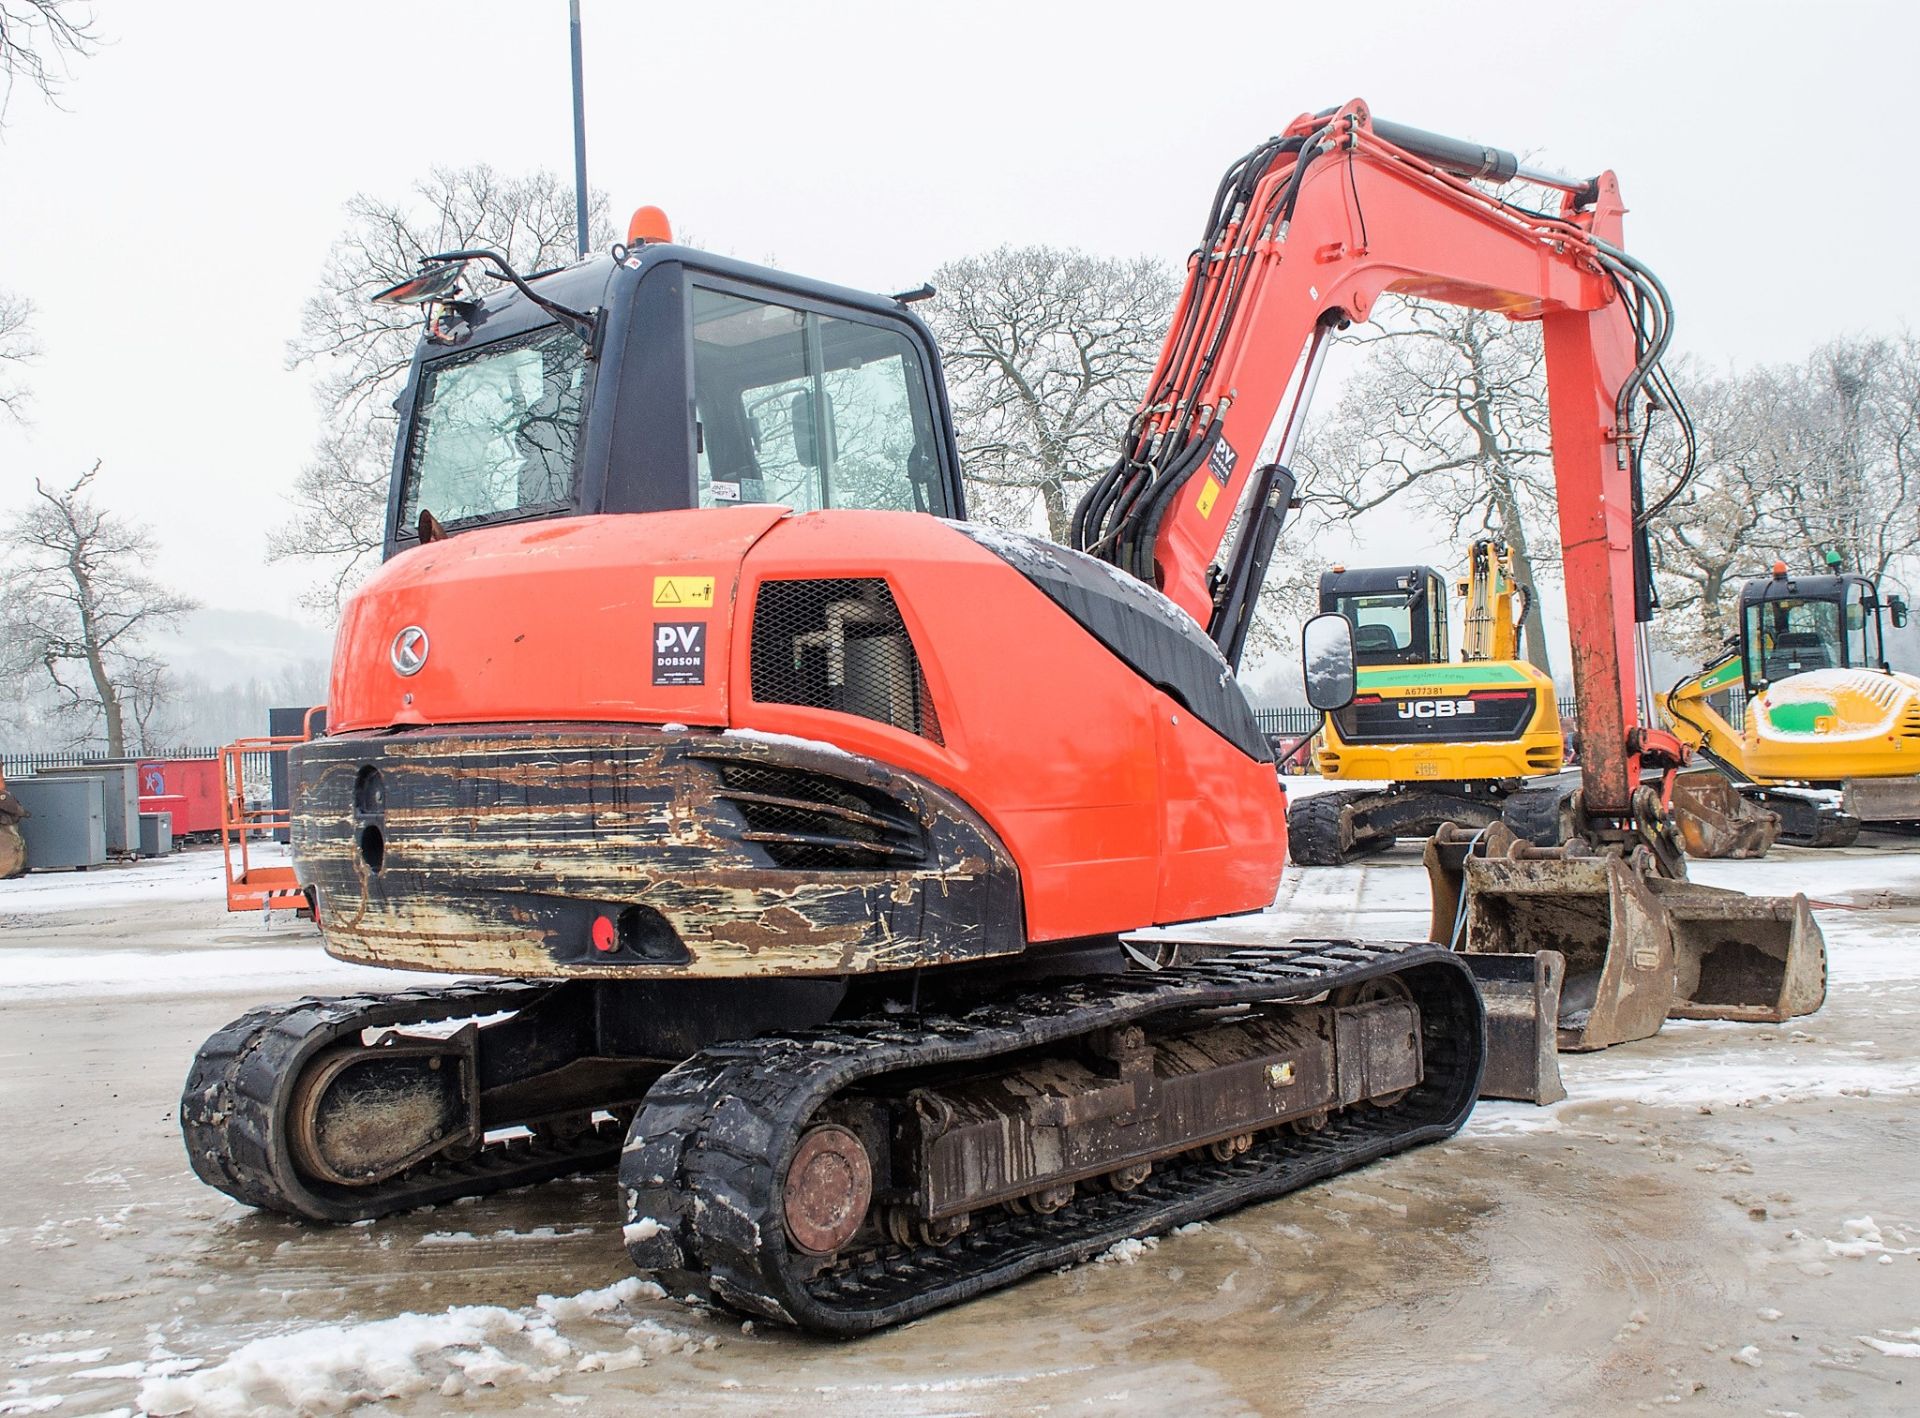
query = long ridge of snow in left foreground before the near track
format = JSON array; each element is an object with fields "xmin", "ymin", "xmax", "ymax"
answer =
[{"xmin": 140, "ymin": 1276, "xmax": 718, "ymax": 1418}]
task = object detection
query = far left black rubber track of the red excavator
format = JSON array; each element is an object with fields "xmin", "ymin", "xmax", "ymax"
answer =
[{"xmin": 180, "ymin": 982, "xmax": 620, "ymax": 1220}]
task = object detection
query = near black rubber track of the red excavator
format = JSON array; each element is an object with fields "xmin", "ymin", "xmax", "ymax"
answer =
[{"xmin": 620, "ymin": 942, "xmax": 1486, "ymax": 1335}]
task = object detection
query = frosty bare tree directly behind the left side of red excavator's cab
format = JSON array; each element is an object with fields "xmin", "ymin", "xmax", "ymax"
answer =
[{"xmin": 267, "ymin": 163, "xmax": 612, "ymax": 608}]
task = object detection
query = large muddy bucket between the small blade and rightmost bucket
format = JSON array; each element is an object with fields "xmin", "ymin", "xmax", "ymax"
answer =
[{"xmin": 1425, "ymin": 823, "xmax": 1674, "ymax": 1053}]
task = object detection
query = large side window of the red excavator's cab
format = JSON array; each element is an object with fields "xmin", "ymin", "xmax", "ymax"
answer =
[{"xmin": 693, "ymin": 286, "xmax": 950, "ymax": 514}]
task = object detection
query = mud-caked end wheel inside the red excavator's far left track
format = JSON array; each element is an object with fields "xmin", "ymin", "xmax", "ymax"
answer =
[{"xmin": 286, "ymin": 1028, "xmax": 480, "ymax": 1186}]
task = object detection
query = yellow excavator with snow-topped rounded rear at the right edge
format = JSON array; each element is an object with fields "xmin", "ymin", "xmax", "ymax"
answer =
[{"xmin": 1665, "ymin": 556, "xmax": 1920, "ymax": 846}]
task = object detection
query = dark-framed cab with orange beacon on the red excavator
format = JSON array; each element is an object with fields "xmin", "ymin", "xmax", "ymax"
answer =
[{"xmin": 384, "ymin": 244, "xmax": 966, "ymax": 560}]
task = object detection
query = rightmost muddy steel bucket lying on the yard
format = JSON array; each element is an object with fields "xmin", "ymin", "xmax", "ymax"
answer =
[{"xmin": 1649, "ymin": 881, "xmax": 1826, "ymax": 1025}]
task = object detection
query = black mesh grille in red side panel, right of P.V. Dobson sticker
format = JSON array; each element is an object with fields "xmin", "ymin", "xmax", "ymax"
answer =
[{"xmin": 753, "ymin": 578, "xmax": 943, "ymax": 743}]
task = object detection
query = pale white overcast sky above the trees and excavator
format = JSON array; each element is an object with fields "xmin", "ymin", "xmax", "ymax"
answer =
[{"xmin": 0, "ymin": 0, "xmax": 1920, "ymax": 633}]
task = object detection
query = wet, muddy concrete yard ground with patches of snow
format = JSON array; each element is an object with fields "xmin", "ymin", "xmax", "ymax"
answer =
[{"xmin": 0, "ymin": 839, "xmax": 1920, "ymax": 1418}]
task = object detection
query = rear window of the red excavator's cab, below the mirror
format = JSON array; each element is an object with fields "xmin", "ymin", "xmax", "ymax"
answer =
[{"xmin": 399, "ymin": 326, "xmax": 588, "ymax": 528}]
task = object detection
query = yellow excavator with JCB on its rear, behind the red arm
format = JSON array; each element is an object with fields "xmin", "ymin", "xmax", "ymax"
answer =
[{"xmin": 1286, "ymin": 539, "xmax": 1565, "ymax": 867}]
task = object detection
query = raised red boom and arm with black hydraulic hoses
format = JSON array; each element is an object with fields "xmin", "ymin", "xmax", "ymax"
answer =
[{"xmin": 1073, "ymin": 100, "xmax": 1659, "ymax": 827}]
